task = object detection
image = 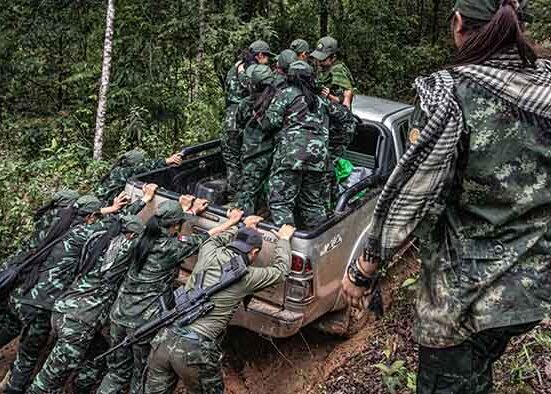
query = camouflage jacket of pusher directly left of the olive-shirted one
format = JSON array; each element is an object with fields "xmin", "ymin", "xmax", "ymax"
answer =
[{"xmin": 110, "ymin": 234, "xmax": 208, "ymax": 328}]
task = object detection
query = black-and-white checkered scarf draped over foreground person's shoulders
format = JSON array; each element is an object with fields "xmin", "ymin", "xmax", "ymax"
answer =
[{"xmin": 366, "ymin": 52, "xmax": 551, "ymax": 261}]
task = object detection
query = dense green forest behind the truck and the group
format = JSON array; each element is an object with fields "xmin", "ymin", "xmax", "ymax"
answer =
[{"xmin": 0, "ymin": 0, "xmax": 551, "ymax": 257}]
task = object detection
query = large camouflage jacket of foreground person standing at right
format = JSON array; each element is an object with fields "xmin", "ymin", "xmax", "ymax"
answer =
[{"xmin": 412, "ymin": 77, "xmax": 551, "ymax": 347}]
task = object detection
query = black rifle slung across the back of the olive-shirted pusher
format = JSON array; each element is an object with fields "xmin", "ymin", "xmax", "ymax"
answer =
[{"xmin": 94, "ymin": 255, "xmax": 248, "ymax": 362}]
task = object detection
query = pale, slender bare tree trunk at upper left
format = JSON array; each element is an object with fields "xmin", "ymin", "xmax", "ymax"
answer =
[{"xmin": 94, "ymin": 0, "xmax": 115, "ymax": 160}]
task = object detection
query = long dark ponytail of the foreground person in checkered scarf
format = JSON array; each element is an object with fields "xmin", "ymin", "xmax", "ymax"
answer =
[{"xmin": 452, "ymin": 0, "xmax": 538, "ymax": 66}]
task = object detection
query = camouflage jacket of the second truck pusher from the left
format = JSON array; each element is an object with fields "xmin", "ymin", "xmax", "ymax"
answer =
[{"xmin": 11, "ymin": 220, "xmax": 108, "ymax": 310}]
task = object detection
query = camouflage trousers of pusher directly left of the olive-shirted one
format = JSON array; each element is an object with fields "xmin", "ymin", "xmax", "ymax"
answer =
[{"xmin": 97, "ymin": 322, "xmax": 151, "ymax": 394}]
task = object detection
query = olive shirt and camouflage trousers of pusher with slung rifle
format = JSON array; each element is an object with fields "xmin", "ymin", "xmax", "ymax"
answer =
[{"xmin": 145, "ymin": 228, "xmax": 291, "ymax": 394}]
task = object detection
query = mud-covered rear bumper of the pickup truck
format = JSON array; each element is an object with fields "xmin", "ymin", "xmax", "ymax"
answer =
[{"xmin": 230, "ymin": 299, "xmax": 304, "ymax": 338}]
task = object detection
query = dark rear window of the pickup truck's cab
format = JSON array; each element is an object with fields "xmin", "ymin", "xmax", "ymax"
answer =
[{"xmin": 344, "ymin": 124, "xmax": 381, "ymax": 170}]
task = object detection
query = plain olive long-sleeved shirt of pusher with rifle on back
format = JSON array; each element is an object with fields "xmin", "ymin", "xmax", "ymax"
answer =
[{"xmin": 176, "ymin": 228, "xmax": 291, "ymax": 339}]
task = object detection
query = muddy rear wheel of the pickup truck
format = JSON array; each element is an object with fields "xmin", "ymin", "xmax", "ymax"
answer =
[{"xmin": 313, "ymin": 300, "xmax": 370, "ymax": 338}]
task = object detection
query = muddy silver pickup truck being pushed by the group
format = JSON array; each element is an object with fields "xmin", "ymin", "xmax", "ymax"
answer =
[{"xmin": 126, "ymin": 96, "xmax": 413, "ymax": 337}]
